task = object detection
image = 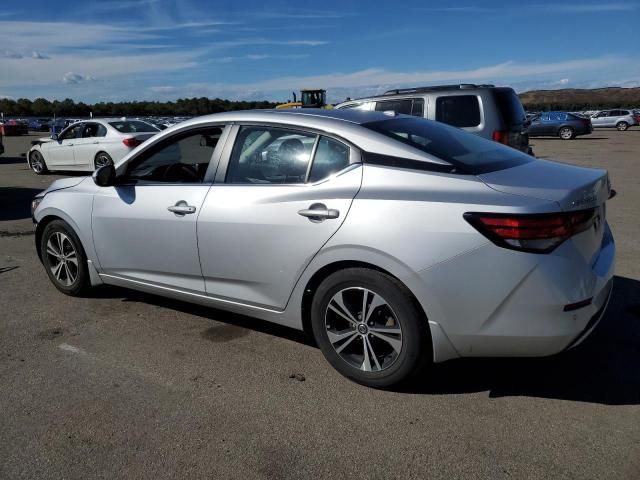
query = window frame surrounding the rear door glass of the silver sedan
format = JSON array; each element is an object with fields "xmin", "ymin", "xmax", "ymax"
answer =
[{"xmin": 213, "ymin": 122, "xmax": 363, "ymax": 187}]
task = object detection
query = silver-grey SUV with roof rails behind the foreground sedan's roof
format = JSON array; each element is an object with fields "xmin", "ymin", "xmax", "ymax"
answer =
[{"xmin": 335, "ymin": 84, "xmax": 532, "ymax": 153}]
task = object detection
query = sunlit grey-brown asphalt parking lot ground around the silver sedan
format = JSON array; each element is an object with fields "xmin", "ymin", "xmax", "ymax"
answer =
[{"xmin": 0, "ymin": 127, "xmax": 640, "ymax": 479}]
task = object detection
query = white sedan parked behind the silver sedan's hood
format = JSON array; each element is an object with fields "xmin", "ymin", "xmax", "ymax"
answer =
[{"xmin": 27, "ymin": 118, "xmax": 160, "ymax": 175}]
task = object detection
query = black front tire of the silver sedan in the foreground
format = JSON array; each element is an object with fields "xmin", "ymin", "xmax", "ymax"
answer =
[{"xmin": 40, "ymin": 220, "xmax": 90, "ymax": 297}]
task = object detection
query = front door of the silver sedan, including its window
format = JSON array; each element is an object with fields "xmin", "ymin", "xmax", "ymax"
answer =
[{"xmin": 93, "ymin": 127, "xmax": 229, "ymax": 293}]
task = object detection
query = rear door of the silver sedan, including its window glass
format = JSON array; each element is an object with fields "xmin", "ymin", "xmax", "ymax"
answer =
[{"xmin": 198, "ymin": 125, "xmax": 362, "ymax": 310}]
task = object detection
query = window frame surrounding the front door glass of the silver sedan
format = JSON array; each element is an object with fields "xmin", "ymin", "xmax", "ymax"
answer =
[{"xmin": 117, "ymin": 123, "xmax": 231, "ymax": 186}]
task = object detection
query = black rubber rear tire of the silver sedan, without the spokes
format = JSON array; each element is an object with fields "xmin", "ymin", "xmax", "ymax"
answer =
[{"xmin": 311, "ymin": 268, "xmax": 433, "ymax": 388}]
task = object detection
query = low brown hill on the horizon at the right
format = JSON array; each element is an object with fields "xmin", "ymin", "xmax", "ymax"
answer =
[{"xmin": 520, "ymin": 87, "xmax": 640, "ymax": 111}]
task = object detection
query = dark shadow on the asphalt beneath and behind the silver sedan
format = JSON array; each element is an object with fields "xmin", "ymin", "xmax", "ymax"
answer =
[{"xmin": 87, "ymin": 276, "xmax": 640, "ymax": 405}]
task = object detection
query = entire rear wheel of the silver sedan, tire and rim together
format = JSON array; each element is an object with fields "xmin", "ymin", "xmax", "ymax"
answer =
[{"xmin": 311, "ymin": 268, "xmax": 431, "ymax": 388}]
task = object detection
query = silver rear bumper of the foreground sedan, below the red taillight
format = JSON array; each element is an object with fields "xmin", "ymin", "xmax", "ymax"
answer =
[{"xmin": 420, "ymin": 225, "xmax": 615, "ymax": 357}]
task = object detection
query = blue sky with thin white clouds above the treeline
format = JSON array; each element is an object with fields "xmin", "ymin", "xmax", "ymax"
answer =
[{"xmin": 0, "ymin": 0, "xmax": 640, "ymax": 102}]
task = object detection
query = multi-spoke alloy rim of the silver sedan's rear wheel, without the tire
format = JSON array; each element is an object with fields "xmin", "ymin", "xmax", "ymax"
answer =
[{"xmin": 325, "ymin": 287, "xmax": 403, "ymax": 372}]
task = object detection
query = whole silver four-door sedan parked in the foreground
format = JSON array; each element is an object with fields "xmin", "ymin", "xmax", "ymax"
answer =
[{"xmin": 32, "ymin": 109, "xmax": 615, "ymax": 387}]
